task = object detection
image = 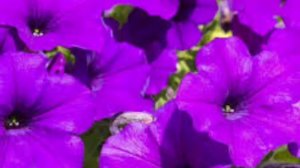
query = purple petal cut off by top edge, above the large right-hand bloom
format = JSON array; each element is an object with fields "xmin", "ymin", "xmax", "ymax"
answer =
[{"xmin": 228, "ymin": 0, "xmax": 282, "ymax": 36}]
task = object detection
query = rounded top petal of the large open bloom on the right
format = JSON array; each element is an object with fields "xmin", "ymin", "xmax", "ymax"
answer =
[{"xmin": 196, "ymin": 38, "xmax": 252, "ymax": 100}]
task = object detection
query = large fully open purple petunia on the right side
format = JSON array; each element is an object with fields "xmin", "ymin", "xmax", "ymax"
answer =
[{"xmin": 177, "ymin": 38, "xmax": 300, "ymax": 167}]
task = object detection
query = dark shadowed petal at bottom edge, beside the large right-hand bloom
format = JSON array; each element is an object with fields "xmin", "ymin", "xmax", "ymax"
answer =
[{"xmin": 156, "ymin": 101, "xmax": 232, "ymax": 168}]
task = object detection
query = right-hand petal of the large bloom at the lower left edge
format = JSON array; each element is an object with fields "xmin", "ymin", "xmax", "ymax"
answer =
[{"xmin": 33, "ymin": 82, "xmax": 95, "ymax": 134}]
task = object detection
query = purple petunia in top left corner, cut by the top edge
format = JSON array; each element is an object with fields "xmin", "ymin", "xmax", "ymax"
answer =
[{"xmin": 0, "ymin": 0, "xmax": 106, "ymax": 50}]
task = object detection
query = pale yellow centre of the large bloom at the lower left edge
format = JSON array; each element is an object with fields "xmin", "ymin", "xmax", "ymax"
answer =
[{"xmin": 4, "ymin": 114, "xmax": 27, "ymax": 130}]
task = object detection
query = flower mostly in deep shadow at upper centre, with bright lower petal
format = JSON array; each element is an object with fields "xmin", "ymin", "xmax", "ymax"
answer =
[{"xmin": 105, "ymin": 9, "xmax": 177, "ymax": 95}]
